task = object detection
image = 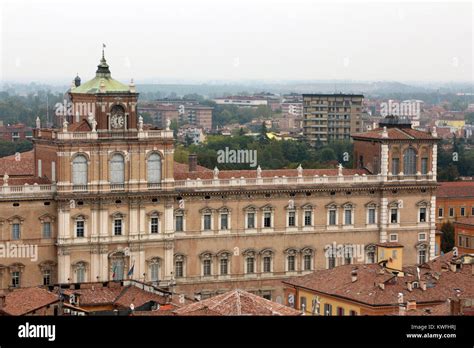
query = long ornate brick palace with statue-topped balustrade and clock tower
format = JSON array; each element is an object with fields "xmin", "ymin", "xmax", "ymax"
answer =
[{"xmin": 0, "ymin": 53, "xmax": 437, "ymax": 303}]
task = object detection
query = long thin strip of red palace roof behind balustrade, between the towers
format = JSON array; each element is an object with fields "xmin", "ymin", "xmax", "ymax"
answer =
[{"xmin": 174, "ymin": 167, "xmax": 369, "ymax": 180}]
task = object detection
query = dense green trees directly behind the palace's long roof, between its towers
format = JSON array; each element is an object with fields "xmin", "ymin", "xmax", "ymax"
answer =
[{"xmin": 175, "ymin": 135, "xmax": 352, "ymax": 170}]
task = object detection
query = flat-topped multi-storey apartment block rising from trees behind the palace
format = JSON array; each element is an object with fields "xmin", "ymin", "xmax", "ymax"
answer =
[{"xmin": 303, "ymin": 94, "xmax": 364, "ymax": 145}]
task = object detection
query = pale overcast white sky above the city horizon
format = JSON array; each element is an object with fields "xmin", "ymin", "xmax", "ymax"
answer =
[{"xmin": 0, "ymin": 0, "xmax": 474, "ymax": 84}]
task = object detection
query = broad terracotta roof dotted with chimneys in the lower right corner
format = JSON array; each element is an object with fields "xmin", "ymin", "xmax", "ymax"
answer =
[{"xmin": 284, "ymin": 253, "xmax": 474, "ymax": 306}]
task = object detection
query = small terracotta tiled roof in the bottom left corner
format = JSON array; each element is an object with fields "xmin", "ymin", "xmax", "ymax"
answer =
[{"xmin": 0, "ymin": 288, "xmax": 59, "ymax": 315}]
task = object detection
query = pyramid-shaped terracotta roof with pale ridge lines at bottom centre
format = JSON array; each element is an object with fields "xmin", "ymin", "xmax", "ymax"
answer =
[{"xmin": 174, "ymin": 289, "xmax": 301, "ymax": 316}]
